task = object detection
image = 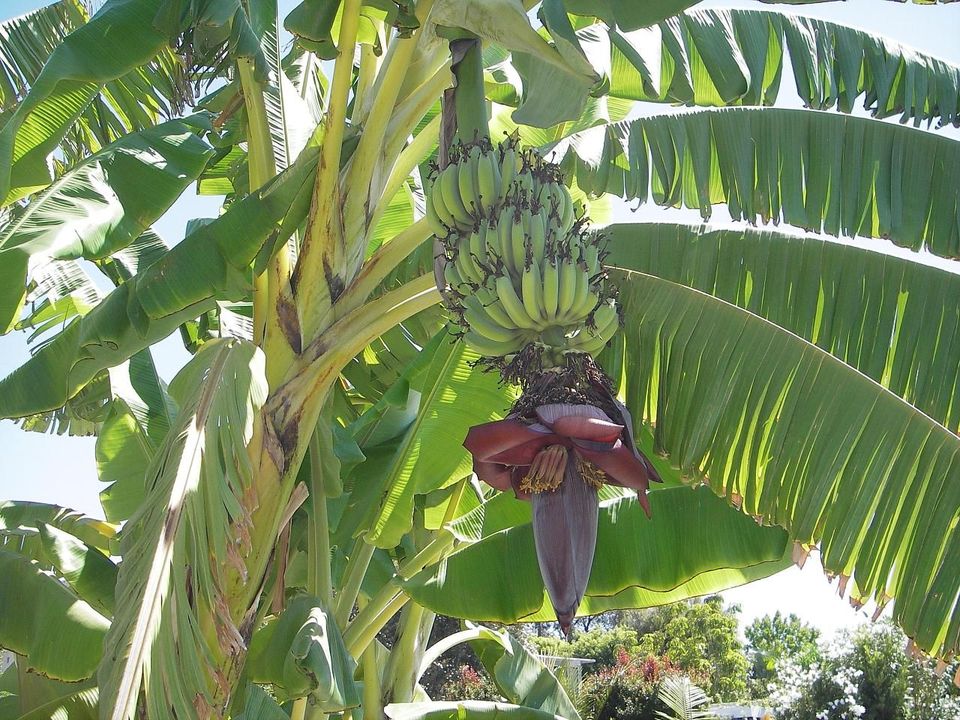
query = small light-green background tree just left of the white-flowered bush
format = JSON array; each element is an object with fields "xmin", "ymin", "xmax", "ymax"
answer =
[{"xmin": 744, "ymin": 610, "xmax": 820, "ymax": 698}]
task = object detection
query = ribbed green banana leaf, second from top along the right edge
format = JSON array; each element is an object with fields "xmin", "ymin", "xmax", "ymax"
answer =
[{"xmin": 563, "ymin": 108, "xmax": 960, "ymax": 258}]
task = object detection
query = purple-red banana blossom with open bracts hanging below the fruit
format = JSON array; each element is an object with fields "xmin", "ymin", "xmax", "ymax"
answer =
[{"xmin": 463, "ymin": 403, "xmax": 660, "ymax": 633}]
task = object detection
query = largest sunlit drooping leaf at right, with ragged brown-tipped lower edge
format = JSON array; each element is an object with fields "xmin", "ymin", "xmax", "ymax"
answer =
[{"xmin": 620, "ymin": 272, "xmax": 960, "ymax": 657}]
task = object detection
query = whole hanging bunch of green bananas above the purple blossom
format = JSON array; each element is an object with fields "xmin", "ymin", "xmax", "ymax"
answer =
[{"xmin": 427, "ymin": 139, "xmax": 620, "ymax": 365}]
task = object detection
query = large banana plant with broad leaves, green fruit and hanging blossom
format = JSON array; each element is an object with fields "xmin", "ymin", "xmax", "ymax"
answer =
[{"xmin": 0, "ymin": 0, "xmax": 960, "ymax": 720}]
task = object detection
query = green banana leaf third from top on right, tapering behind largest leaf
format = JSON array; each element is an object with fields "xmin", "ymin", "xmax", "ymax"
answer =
[{"xmin": 604, "ymin": 223, "xmax": 960, "ymax": 432}]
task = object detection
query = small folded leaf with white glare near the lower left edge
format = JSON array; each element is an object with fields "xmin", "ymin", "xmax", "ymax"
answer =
[{"xmin": 37, "ymin": 523, "xmax": 117, "ymax": 618}]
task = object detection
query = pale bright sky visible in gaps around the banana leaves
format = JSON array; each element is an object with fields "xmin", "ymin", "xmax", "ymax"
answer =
[{"xmin": 0, "ymin": 0, "xmax": 960, "ymax": 633}]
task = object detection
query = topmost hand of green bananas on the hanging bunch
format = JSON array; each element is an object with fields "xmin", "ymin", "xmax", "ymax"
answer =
[{"xmin": 427, "ymin": 137, "xmax": 574, "ymax": 238}]
